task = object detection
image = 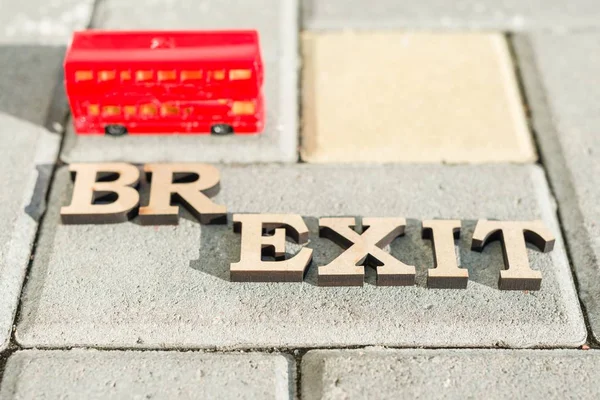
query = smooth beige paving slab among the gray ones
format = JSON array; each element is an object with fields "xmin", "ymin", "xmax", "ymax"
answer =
[{"xmin": 302, "ymin": 32, "xmax": 536, "ymax": 163}]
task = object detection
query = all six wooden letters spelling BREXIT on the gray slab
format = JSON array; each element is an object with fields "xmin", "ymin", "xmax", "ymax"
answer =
[{"xmin": 61, "ymin": 163, "xmax": 555, "ymax": 290}]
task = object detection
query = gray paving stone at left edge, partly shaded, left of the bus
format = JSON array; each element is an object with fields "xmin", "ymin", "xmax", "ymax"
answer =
[{"xmin": 0, "ymin": 40, "xmax": 64, "ymax": 349}]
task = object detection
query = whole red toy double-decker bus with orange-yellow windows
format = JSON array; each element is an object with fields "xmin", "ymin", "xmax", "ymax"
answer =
[{"xmin": 64, "ymin": 30, "xmax": 265, "ymax": 136}]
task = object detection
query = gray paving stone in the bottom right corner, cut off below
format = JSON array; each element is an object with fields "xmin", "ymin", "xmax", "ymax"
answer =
[{"xmin": 302, "ymin": 349, "xmax": 600, "ymax": 400}]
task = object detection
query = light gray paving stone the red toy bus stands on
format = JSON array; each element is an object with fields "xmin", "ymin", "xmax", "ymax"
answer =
[{"xmin": 62, "ymin": 0, "xmax": 298, "ymax": 163}]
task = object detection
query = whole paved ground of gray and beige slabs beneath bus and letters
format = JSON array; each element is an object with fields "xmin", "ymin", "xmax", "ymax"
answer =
[{"xmin": 0, "ymin": 0, "xmax": 600, "ymax": 400}]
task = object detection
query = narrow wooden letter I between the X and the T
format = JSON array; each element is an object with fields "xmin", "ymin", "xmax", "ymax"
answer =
[{"xmin": 421, "ymin": 220, "xmax": 469, "ymax": 289}]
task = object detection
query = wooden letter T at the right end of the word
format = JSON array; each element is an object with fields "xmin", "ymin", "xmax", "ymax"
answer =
[{"xmin": 471, "ymin": 219, "xmax": 554, "ymax": 290}]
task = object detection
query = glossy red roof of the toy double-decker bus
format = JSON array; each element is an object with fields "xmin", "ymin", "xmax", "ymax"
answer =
[{"xmin": 65, "ymin": 30, "xmax": 260, "ymax": 64}]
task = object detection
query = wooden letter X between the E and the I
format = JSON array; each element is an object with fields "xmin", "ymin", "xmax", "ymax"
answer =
[{"xmin": 319, "ymin": 218, "xmax": 415, "ymax": 286}]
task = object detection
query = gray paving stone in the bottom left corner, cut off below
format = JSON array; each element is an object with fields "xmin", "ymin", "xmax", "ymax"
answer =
[{"xmin": 0, "ymin": 350, "xmax": 295, "ymax": 400}]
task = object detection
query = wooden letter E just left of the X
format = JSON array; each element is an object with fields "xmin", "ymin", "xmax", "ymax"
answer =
[{"xmin": 230, "ymin": 214, "xmax": 312, "ymax": 282}]
